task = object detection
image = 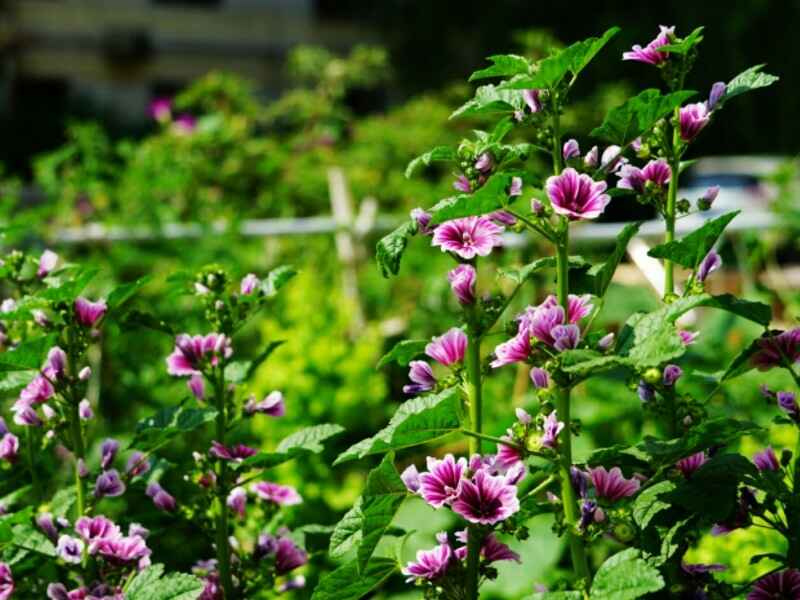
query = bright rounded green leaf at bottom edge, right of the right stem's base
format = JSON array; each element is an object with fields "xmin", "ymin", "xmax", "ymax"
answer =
[{"xmin": 589, "ymin": 548, "xmax": 664, "ymax": 600}]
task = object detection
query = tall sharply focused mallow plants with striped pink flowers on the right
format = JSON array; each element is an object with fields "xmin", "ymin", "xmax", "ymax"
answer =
[{"xmin": 314, "ymin": 27, "xmax": 800, "ymax": 600}]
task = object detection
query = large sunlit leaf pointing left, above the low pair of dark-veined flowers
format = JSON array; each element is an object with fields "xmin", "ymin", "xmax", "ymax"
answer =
[{"xmin": 333, "ymin": 388, "xmax": 461, "ymax": 465}]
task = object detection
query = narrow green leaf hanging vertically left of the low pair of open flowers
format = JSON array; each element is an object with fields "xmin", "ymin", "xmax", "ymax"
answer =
[{"xmin": 358, "ymin": 452, "xmax": 408, "ymax": 571}]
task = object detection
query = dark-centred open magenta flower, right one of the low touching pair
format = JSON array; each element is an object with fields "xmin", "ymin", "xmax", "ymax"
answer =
[{"xmin": 453, "ymin": 470, "xmax": 519, "ymax": 525}]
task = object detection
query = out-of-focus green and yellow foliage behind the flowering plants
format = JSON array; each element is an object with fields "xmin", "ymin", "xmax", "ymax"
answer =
[{"xmin": 0, "ymin": 0, "xmax": 800, "ymax": 598}]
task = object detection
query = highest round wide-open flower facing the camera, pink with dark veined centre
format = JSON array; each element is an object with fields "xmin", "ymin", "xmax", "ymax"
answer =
[{"xmin": 546, "ymin": 167, "xmax": 611, "ymax": 221}]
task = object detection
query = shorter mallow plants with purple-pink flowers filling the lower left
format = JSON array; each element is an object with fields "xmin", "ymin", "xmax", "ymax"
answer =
[{"xmin": 0, "ymin": 250, "xmax": 341, "ymax": 600}]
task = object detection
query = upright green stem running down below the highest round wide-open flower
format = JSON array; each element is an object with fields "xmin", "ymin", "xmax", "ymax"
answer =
[{"xmin": 556, "ymin": 223, "xmax": 591, "ymax": 586}]
